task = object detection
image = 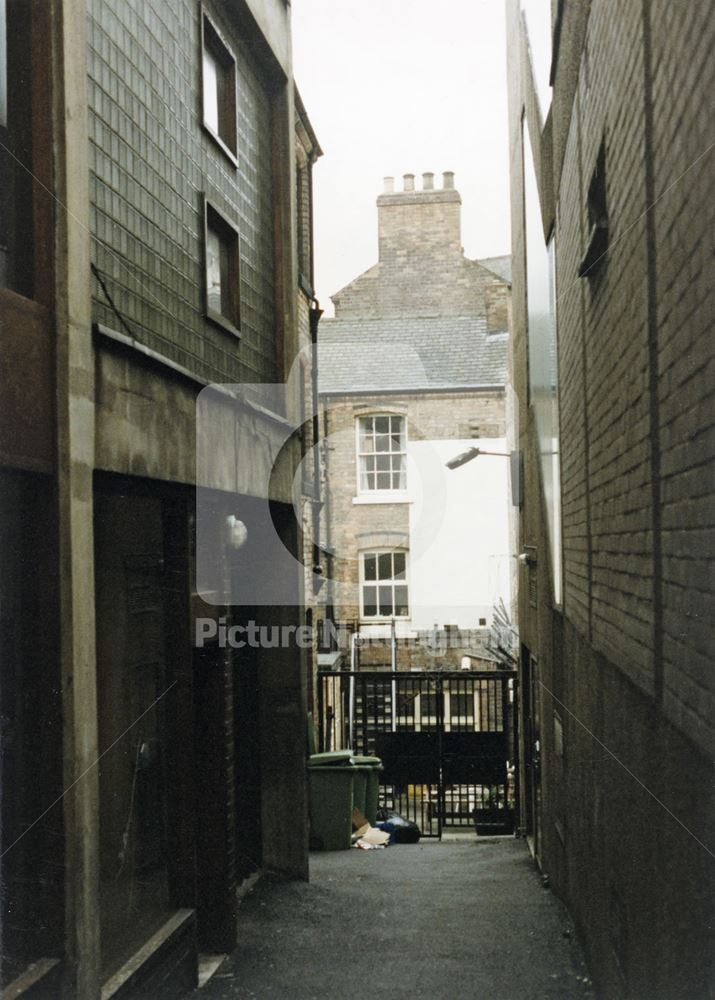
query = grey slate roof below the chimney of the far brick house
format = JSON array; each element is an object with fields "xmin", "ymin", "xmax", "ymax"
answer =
[{"xmin": 318, "ymin": 316, "xmax": 508, "ymax": 394}]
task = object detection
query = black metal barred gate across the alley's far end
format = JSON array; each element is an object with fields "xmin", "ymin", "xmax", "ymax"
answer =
[{"xmin": 318, "ymin": 670, "xmax": 518, "ymax": 837}]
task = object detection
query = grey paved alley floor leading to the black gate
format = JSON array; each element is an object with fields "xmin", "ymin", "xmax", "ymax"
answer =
[{"xmin": 192, "ymin": 838, "xmax": 593, "ymax": 1000}]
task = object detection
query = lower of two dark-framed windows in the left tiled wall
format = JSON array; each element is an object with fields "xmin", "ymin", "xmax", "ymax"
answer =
[{"xmin": 205, "ymin": 202, "xmax": 241, "ymax": 334}]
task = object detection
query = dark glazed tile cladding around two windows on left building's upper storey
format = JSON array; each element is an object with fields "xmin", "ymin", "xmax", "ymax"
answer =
[{"xmin": 88, "ymin": 0, "xmax": 276, "ymax": 382}]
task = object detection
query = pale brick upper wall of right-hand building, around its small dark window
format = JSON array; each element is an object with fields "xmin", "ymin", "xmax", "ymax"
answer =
[{"xmin": 557, "ymin": 3, "xmax": 714, "ymax": 742}]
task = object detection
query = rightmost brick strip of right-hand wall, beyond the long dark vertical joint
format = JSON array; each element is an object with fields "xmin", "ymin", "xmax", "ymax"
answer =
[{"xmin": 650, "ymin": 0, "xmax": 715, "ymax": 746}]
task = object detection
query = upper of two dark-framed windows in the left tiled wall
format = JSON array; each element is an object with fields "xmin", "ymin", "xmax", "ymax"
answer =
[{"xmin": 201, "ymin": 14, "xmax": 237, "ymax": 162}]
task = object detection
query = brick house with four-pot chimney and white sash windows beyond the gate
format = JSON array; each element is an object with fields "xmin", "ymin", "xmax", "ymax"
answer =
[{"xmin": 318, "ymin": 173, "xmax": 511, "ymax": 669}]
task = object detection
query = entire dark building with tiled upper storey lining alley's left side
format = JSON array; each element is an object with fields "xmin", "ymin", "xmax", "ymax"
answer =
[{"xmin": 0, "ymin": 0, "xmax": 320, "ymax": 1000}]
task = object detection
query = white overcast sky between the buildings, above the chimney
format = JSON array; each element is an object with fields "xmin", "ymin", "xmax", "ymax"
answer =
[{"xmin": 292, "ymin": 0, "xmax": 510, "ymax": 315}]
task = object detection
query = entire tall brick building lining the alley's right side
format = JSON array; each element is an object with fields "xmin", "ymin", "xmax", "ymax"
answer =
[{"xmin": 508, "ymin": 0, "xmax": 715, "ymax": 998}]
